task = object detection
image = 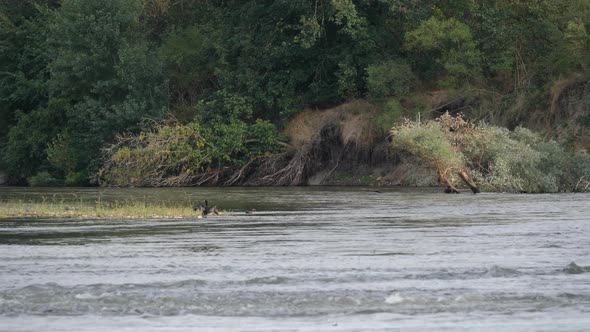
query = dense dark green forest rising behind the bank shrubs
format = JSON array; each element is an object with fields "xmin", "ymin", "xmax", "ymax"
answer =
[{"xmin": 0, "ymin": 0, "xmax": 590, "ymax": 184}]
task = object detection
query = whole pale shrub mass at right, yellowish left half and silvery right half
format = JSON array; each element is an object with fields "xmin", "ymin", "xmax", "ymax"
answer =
[{"xmin": 391, "ymin": 113, "xmax": 590, "ymax": 193}]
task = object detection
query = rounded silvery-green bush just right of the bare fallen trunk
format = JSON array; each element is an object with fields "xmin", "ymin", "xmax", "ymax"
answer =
[{"xmin": 464, "ymin": 126, "xmax": 590, "ymax": 192}]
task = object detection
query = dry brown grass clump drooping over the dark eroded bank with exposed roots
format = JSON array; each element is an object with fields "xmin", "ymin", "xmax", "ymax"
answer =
[{"xmin": 256, "ymin": 101, "xmax": 378, "ymax": 185}]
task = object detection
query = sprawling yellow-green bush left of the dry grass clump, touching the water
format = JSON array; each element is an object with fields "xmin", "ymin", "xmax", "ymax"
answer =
[{"xmin": 99, "ymin": 121, "xmax": 280, "ymax": 186}]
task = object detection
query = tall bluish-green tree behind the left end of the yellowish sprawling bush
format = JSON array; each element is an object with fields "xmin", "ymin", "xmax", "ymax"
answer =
[{"xmin": 6, "ymin": 0, "xmax": 166, "ymax": 184}]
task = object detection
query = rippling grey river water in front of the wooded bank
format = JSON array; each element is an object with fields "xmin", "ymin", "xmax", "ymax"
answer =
[{"xmin": 0, "ymin": 188, "xmax": 590, "ymax": 331}]
